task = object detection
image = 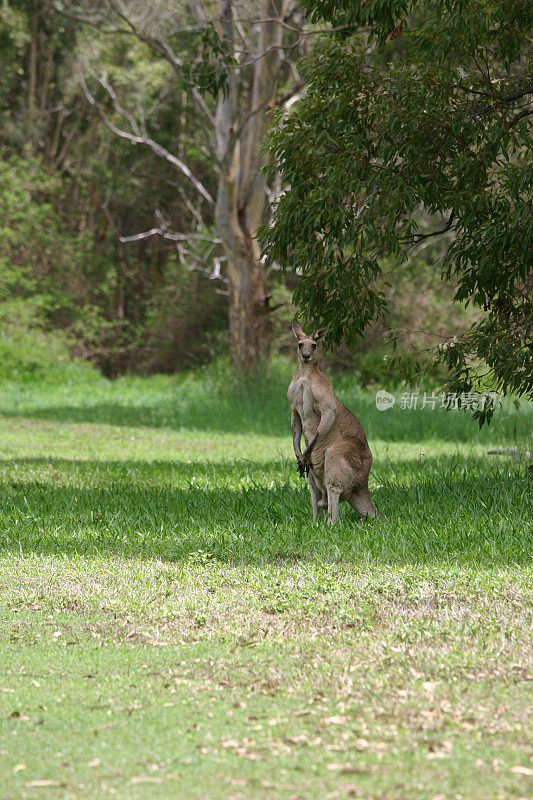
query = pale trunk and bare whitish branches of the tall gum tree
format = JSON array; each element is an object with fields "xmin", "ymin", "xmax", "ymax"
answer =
[{"xmin": 71, "ymin": 0, "xmax": 295, "ymax": 374}]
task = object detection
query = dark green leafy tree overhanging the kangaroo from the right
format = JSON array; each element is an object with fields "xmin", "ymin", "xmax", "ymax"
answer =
[{"xmin": 265, "ymin": 0, "xmax": 533, "ymax": 424}]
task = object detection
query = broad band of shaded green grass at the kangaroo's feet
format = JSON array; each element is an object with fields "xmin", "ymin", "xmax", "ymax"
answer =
[{"xmin": 0, "ymin": 459, "xmax": 533, "ymax": 566}]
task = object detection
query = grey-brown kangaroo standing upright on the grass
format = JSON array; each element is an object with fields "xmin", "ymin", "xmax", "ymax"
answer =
[{"xmin": 287, "ymin": 322, "xmax": 379, "ymax": 523}]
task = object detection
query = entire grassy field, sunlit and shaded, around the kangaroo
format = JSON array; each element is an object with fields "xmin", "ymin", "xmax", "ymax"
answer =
[{"xmin": 0, "ymin": 367, "xmax": 533, "ymax": 800}]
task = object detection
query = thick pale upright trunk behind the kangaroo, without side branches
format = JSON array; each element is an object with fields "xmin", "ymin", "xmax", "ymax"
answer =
[{"xmin": 216, "ymin": 0, "xmax": 285, "ymax": 376}]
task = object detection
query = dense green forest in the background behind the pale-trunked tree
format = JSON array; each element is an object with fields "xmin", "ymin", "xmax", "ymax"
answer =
[{"xmin": 0, "ymin": 0, "xmax": 476, "ymax": 384}]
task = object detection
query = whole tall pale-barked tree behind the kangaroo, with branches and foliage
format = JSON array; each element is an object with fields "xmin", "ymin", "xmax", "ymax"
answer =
[{"xmin": 53, "ymin": 0, "xmax": 303, "ymax": 374}]
